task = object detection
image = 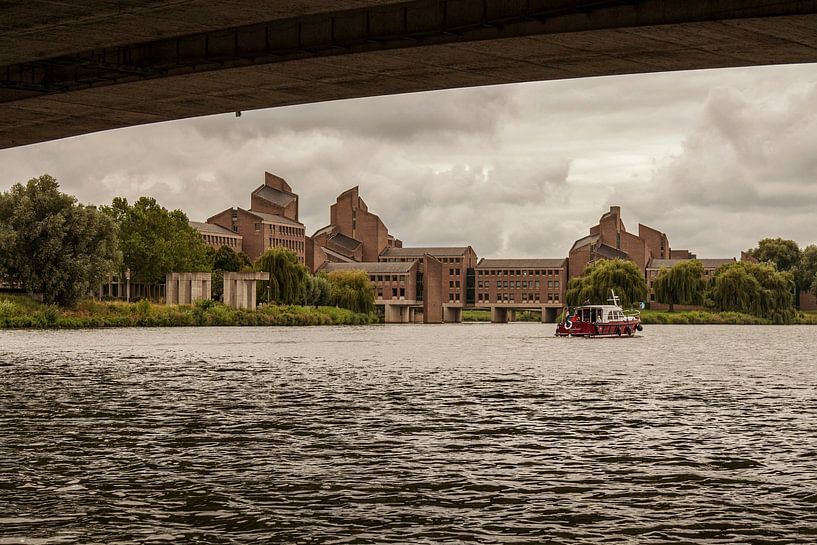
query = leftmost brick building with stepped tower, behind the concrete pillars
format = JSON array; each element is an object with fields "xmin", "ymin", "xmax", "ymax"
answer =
[{"xmin": 207, "ymin": 172, "xmax": 306, "ymax": 263}]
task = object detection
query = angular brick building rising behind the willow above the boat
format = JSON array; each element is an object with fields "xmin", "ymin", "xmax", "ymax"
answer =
[{"xmin": 568, "ymin": 206, "xmax": 671, "ymax": 278}]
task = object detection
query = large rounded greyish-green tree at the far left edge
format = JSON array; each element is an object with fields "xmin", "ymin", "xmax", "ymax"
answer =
[{"xmin": 0, "ymin": 174, "xmax": 116, "ymax": 306}]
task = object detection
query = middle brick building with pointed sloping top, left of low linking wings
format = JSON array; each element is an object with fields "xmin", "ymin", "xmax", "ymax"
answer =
[{"xmin": 307, "ymin": 186, "xmax": 402, "ymax": 272}]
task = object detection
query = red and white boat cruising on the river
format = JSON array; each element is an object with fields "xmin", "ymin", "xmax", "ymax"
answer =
[{"xmin": 556, "ymin": 290, "xmax": 643, "ymax": 337}]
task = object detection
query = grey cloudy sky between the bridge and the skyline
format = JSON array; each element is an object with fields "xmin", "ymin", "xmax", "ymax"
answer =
[{"xmin": 0, "ymin": 65, "xmax": 817, "ymax": 257}]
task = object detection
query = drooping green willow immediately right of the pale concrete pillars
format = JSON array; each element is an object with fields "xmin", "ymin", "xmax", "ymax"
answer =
[{"xmin": 255, "ymin": 248, "xmax": 310, "ymax": 305}]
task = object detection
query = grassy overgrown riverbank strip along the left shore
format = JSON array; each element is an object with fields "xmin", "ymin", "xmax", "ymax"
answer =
[{"xmin": 0, "ymin": 295, "xmax": 378, "ymax": 329}]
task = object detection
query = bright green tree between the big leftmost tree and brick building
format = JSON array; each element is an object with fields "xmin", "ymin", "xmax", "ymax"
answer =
[{"xmin": 104, "ymin": 197, "xmax": 212, "ymax": 284}]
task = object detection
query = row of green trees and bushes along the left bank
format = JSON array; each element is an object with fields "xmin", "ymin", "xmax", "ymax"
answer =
[{"xmin": 0, "ymin": 174, "xmax": 374, "ymax": 313}]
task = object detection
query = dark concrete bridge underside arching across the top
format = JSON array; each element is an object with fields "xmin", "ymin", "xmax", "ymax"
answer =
[{"xmin": 0, "ymin": 0, "xmax": 817, "ymax": 148}]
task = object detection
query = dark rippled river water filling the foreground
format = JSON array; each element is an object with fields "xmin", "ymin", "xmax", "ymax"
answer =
[{"xmin": 0, "ymin": 323, "xmax": 817, "ymax": 545}]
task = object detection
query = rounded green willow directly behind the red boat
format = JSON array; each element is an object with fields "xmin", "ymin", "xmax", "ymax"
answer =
[{"xmin": 565, "ymin": 259, "xmax": 647, "ymax": 306}]
